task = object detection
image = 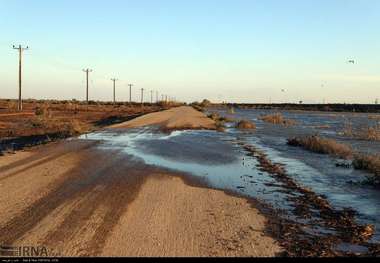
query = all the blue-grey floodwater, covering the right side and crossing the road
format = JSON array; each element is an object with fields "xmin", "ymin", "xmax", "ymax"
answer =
[{"xmin": 79, "ymin": 109, "xmax": 380, "ymax": 251}]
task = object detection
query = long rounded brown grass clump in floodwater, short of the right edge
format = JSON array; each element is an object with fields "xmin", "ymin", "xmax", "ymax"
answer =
[{"xmin": 288, "ymin": 136, "xmax": 353, "ymax": 159}]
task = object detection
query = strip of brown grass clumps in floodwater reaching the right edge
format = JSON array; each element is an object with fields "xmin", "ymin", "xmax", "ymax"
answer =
[{"xmin": 288, "ymin": 136, "xmax": 380, "ymax": 186}]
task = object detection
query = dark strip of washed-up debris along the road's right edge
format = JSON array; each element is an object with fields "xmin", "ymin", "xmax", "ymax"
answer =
[{"xmin": 238, "ymin": 142, "xmax": 379, "ymax": 257}]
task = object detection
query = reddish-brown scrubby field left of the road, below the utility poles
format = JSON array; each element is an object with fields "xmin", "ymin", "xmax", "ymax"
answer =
[{"xmin": 0, "ymin": 100, "xmax": 172, "ymax": 155}]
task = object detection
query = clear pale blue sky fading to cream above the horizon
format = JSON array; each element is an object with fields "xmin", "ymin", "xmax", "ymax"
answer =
[{"xmin": 0, "ymin": 0, "xmax": 380, "ymax": 103}]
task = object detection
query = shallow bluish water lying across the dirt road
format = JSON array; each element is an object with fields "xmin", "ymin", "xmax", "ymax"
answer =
[{"xmin": 80, "ymin": 129, "xmax": 286, "ymax": 208}]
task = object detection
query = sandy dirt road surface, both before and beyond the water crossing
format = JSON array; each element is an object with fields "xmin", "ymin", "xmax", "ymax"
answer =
[{"xmin": 0, "ymin": 107, "xmax": 281, "ymax": 256}]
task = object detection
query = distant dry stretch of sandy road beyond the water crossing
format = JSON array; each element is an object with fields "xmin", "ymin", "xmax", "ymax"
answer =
[{"xmin": 111, "ymin": 106, "xmax": 215, "ymax": 130}]
